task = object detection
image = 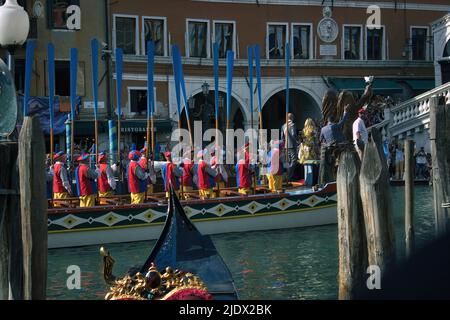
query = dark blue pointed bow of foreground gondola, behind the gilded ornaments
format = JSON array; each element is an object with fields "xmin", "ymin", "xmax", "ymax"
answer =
[{"xmin": 141, "ymin": 187, "xmax": 238, "ymax": 300}]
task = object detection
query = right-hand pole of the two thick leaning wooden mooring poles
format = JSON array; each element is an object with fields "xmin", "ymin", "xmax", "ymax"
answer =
[{"xmin": 359, "ymin": 129, "xmax": 395, "ymax": 275}]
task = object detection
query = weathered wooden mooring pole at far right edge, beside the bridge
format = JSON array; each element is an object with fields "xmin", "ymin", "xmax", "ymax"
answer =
[{"xmin": 430, "ymin": 96, "xmax": 450, "ymax": 237}]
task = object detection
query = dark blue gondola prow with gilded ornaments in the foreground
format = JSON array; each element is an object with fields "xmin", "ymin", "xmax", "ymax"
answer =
[{"xmin": 100, "ymin": 188, "xmax": 238, "ymax": 300}]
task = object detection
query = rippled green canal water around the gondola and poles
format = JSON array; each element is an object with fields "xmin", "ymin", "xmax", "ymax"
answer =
[{"xmin": 47, "ymin": 186, "xmax": 434, "ymax": 300}]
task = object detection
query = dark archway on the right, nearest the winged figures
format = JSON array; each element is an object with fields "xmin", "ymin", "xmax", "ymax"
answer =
[{"xmin": 262, "ymin": 89, "xmax": 322, "ymax": 135}]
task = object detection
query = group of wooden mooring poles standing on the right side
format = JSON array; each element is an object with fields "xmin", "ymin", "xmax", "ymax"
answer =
[{"xmin": 337, "ymin": 97, "xmax": 450, "ymax": 300}]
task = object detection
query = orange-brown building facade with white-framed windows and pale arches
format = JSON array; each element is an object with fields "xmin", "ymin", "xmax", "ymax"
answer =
[{"xmin": 110, "ymin": 0, "xmax": 450, "ymax": 148}]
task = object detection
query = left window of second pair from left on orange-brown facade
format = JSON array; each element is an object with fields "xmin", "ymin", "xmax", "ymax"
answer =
[{"xmin": 187, "ymin": 20, "xmax": 210, "ymax": 58}]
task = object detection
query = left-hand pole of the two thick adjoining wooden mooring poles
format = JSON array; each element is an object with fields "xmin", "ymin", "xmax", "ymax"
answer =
[{"xmin": 336, "ymin": 151, "xmax": 367, "ymax": 300}]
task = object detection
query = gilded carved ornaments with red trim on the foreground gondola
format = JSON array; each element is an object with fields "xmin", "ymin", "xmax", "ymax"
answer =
[{"xmin": 101, "ymin": 248, "xmax": 213, "ymax": 300}]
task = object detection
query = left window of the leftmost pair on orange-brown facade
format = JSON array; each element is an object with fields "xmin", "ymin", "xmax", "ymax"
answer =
[{"xmin": 114, "ymin": 15, "xmax": 139, "ymax": 55}]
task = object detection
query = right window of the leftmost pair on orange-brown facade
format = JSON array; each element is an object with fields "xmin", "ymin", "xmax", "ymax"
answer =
[{"xmin": 142, "ymin": 17, "xmax": 167, "ymax": 56}]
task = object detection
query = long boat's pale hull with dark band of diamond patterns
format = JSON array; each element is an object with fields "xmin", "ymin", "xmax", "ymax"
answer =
[{"xmin": 48, "ymin": 183, "xmax": 337, "ymax": 248}]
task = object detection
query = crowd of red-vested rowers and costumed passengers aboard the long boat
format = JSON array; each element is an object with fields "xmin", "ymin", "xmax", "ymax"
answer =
[{"xmin": 47, "ymin": 84, "xmax": 431, "ymax": 207}]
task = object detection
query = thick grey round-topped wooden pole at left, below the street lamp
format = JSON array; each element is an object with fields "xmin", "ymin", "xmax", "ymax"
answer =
[{"xmin": 18, "ymin": 117, "xmax": 48, "ymax": 300}]
